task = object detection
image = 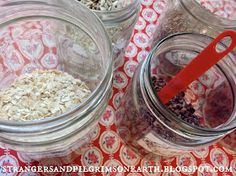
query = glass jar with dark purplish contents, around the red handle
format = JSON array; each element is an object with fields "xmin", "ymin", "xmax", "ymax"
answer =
[{"xmin": 116, "ymin": 33, "xmax": 236, "ymax": 157}]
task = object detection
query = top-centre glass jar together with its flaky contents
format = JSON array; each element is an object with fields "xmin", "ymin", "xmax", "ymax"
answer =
[{"xmin": 77, "ymin": 0, "xmax": 140, "ymax": 70}]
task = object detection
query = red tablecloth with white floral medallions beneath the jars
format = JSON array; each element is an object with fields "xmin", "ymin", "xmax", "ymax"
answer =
[{"xmin": 0, "ymin": 0, "xmax": 236, "ymax": 176}]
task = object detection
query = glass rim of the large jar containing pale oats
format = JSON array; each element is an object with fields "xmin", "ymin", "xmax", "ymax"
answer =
[{"xmin": 0, "ymin": 0, "xmax": 113, "ymax": 133}]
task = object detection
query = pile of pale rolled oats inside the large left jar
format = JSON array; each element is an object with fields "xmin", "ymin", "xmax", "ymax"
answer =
[{"xmin": 0, "ymin": 70, "xmax": 91, "ymax": 121}]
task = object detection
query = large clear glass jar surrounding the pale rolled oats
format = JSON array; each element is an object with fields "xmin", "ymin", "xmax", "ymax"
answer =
[{"xmin": 0, "ymin": 0, "xmax": 113, "ymax": 159}]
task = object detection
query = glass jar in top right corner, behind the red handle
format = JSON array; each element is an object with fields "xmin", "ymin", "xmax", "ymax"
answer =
[{"xmin": 152, "ymin": 0, "xmax": 236, "ymax": 46}]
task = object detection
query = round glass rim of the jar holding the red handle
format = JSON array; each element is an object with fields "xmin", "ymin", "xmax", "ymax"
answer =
[{"xmin": 143, "ymin": 32, "xmax": 236, "ymax": 135}]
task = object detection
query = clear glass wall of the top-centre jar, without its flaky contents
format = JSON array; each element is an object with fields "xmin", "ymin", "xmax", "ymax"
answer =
[{"xmin": 93, "ymin": 0, "xmax": 141, "ymax": 70}]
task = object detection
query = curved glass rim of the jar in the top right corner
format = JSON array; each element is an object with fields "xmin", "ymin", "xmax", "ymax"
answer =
[{"xmin": 179, "ymin": 0, "xmax": 236, "ymax": 29}]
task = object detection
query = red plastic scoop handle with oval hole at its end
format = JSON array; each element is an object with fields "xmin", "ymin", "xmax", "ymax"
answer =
[{"xmin": 158, "ymin": 30, "xmax": 236, "ymax": 104}]
